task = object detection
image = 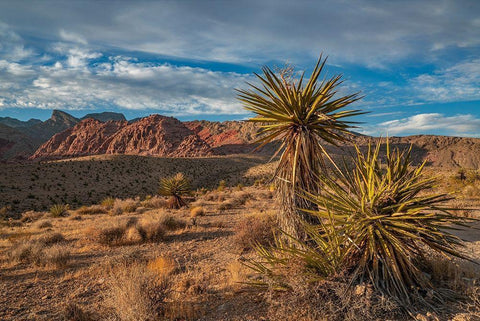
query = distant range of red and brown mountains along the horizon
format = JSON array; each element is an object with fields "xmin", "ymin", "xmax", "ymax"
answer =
[{"xmin": 0, "ymin": 110, "xmax": 480, "ymax": 169}]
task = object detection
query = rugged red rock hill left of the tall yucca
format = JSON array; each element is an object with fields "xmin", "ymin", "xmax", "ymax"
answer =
[{"xmin": 31, "ymin": 115, "xmax": 212, "ymax": 159}]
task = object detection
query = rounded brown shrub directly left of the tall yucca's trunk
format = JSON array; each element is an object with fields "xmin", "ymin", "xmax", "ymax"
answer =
[{"xmin": 234, "ymin": 213, "xmax": 275, "ymax": 250}]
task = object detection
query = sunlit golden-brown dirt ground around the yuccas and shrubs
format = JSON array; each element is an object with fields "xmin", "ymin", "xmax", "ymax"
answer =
[{"xmin": 0, "ymin": 161, "xmax": 480, "ymax": 321}]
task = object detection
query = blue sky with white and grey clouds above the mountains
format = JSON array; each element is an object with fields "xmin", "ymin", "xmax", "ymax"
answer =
[{"xmin": 0, "ymin": 0, "xmax": 480, "ymax": 137}]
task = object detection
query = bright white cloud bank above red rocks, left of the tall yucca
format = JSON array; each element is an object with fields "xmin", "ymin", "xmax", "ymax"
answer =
[{"xmin": 0, "ymin": 43, "xmax": 255, "ymax": 115}]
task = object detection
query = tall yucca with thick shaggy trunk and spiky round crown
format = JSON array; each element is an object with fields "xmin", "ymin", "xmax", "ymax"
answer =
[{"xmin": 238, "ymin": 56, "xmax": 360, "ymax": 237}]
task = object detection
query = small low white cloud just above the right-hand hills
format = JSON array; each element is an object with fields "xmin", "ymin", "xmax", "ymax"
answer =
[{"xmin": 359, "ymin": 113, "xmax": 480, "ymax": 137}]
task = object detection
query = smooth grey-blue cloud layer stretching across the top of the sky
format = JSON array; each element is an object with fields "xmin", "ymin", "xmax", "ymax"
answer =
[{"xmin": 0, "ymin": 0, "xmax": 480, "ymax": 67}]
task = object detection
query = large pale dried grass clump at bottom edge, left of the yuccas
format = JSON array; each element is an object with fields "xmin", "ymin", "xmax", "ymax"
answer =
[{"xmin": 104, "ymin": 263, "xmax": 167, "ymax": 321}]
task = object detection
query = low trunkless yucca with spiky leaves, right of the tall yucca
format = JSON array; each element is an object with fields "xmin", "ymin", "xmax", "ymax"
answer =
[{"xmin": 306, "ymin": 140, "xmax": 472, "ymax": 305}]
